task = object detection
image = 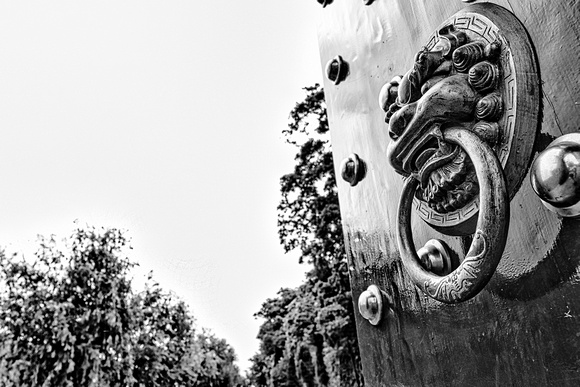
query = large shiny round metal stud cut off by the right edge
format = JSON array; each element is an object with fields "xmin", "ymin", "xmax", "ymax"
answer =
[{"xmin": 530, "ymin": 133, "xmax": 580, "ymax": 217}]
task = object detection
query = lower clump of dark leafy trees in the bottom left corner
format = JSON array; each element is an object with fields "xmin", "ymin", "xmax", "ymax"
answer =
[{"xmin": 0, "ymin": 228, "xmax": 241, "ymax": 387}]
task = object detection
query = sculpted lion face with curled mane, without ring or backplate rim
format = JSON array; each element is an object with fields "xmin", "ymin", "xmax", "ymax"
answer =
[{"xmin": 379, "ymin": 25, "xmax": 503, "ymax": 214}]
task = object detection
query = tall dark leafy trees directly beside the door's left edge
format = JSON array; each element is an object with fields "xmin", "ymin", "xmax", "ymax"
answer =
[{"xmin": 249, "ymin": 85, "xmax": 364, "ymax": 387}]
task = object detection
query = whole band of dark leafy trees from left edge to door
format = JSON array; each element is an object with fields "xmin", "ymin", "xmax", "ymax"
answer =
[{"xmin": 0, "ymin": 85, "xmax": 364, "ymax": 387}]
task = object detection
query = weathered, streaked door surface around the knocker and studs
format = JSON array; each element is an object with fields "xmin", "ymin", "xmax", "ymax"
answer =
[{"xmin": 319, "ymin": 0, "xmax": 580, "ymax": 386}]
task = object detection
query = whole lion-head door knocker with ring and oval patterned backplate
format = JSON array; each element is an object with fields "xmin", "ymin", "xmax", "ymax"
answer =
[{"xmin": 379, "ymin": 4, "xmax": 540, "ymax": 303}]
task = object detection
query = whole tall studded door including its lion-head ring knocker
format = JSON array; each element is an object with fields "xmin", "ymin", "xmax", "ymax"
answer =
[{"xmin": 319, "ymin": 0, "xmax": 580, "ymax": 386}]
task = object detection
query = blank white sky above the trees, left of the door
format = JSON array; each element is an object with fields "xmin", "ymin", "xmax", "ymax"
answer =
[{"xmin": 0, "ymin": 0, "xmax": 322, "ymax": 369}]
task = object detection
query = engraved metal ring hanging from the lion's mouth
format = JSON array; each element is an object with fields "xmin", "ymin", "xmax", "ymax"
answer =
[{"xmin": 397, "ymin": 128, "xmax": 509, "ymax": 304}]
